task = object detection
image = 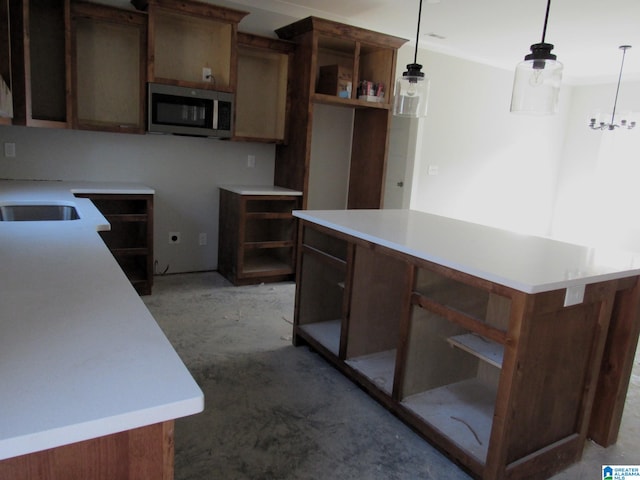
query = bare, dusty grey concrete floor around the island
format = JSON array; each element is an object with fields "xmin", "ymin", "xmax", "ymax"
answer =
[{"xmin": 143, "ymin": 272, "xmax": 640, "ymax": 480}]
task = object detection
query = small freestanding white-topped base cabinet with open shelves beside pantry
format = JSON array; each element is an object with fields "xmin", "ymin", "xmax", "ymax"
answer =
[{"xmin": 218, "ymin": 185, "xmax": 301, "ymax": 285}]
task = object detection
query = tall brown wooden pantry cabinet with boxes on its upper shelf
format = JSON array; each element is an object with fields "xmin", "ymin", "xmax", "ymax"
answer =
[{"xmin": 274, "ymin": 17, "xmax": 406, "ymax": 209}]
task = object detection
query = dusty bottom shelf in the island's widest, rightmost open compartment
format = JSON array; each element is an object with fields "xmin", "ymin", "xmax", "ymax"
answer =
[{"xmin": 401, "ymin": 379, "xmax": 497, "ymax": 463}]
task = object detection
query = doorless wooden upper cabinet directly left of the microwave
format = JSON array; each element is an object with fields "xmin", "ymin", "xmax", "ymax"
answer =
[{"xmin": 68, "ymin": 2, "xmax": 147, "ymax": 133}]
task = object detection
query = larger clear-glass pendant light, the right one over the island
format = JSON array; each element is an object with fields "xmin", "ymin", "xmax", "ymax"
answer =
[{"xmin": 511, "ymin": 0, "xmax": 562, "ymax": 115}]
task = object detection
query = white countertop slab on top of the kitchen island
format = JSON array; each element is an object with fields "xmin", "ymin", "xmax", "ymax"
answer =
[{"xmin": 293, "ymin": 210, "xmax": 640, "ymax": 298}]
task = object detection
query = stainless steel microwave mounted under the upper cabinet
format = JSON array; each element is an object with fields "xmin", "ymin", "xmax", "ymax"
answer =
[{"xmin": 147, "ymin": 83, "xmax": 233, "ymax": 138}]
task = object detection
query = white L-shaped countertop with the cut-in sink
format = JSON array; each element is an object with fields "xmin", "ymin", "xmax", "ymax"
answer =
[{"xmin": 0, "ymin": 181, "xmax": 204, "ymax": 460}]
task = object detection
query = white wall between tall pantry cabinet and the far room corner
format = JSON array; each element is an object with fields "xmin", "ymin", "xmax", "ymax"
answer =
[{"xmin": 397, "ymin": 46, "xmax": 571, "ymax": 234}]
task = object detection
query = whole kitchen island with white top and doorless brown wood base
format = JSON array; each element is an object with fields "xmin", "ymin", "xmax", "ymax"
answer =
[{"xmin": 293, "ymin": 210, "xmax": 640, "ymax": 479}]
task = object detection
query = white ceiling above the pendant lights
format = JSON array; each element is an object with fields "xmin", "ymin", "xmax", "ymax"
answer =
[{"xmin": 93, "ymin": 0, "xmax": 640, "ymax": 84}]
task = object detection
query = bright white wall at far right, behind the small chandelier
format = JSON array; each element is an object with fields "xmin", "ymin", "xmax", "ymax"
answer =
[{"xmin": 553, "ymin": 81, "xmax": 640, "ymax": 251}]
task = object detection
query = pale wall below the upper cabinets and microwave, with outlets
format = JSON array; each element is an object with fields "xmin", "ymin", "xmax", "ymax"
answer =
[{"xmin": 0, "ymin": 126, "xmax": 275, "ymax": 273}]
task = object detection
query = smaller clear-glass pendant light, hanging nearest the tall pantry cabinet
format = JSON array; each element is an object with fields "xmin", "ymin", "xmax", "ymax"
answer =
[{"xmin": 393, "ymin": 0, "xmax": 429, "ymax": 118}]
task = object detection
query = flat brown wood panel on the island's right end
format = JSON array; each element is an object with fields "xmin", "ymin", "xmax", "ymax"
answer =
[{"xmin": 507, "ymin": 284, "xmax": 613, "ymax": 463}]
